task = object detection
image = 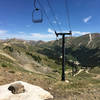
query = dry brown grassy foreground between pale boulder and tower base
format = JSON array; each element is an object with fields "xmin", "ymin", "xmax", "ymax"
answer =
[{"xmin": 0, "ymin": 67, "xmax": 100, "ymax": 100}]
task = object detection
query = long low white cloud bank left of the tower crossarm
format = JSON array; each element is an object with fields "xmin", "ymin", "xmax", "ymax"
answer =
[{"xmin": 0, "ymin": 30, "xmax": 56, "ymax": 41}]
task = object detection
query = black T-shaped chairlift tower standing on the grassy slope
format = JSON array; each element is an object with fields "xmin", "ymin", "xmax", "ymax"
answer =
[{"xmin": 55, "ymin": 31, "xmax": 72, "ymax": 81}]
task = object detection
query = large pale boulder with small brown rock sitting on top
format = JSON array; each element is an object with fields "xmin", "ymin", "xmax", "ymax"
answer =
[{"xmin": 0, "ymin": 81, "xmax": 53, "ymax": 100}]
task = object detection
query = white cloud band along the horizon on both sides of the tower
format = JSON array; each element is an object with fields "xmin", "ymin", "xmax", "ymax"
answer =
[{"xmin": 0, "ymin": 28, "xmax": 90, "ymax": 41}]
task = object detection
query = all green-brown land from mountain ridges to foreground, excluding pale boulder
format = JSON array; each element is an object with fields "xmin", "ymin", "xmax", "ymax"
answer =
[{"xmin": 0, "ymin": 34, "xmax": 100, "ymax": 100}]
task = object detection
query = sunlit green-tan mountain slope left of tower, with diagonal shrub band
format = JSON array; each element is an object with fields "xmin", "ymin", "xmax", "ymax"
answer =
[{"xmin": 0, "ymin": 39, "xmax": 59, "ymax": 72}]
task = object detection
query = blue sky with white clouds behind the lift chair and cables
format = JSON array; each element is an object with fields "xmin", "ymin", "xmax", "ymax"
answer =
[{"xmin": 0, "ymin": 0, "xmax": 100, "ymax": 41}]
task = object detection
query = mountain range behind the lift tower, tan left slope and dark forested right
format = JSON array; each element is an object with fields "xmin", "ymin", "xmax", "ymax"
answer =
[{"xmin": 0, "ymin": 33, "xmax": 100, "ymax": 71}]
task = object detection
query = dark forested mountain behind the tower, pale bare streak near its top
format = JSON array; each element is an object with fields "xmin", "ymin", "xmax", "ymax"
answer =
[{"xmin": 38, "ymin": 33, "xmax": 100, "ymax": 68}]
